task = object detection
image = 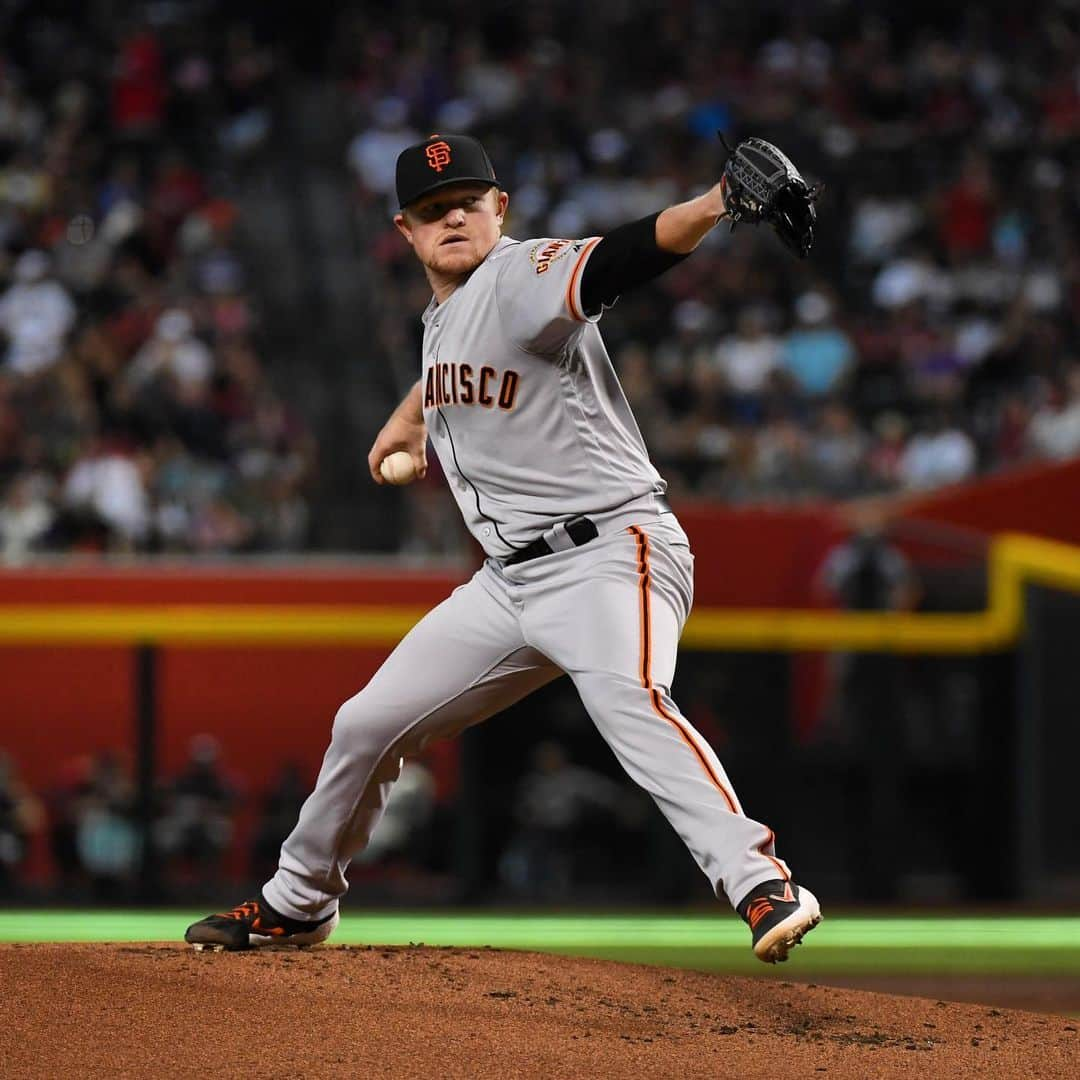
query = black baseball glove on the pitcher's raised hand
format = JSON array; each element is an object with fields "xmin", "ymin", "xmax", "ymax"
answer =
[{"xmin": 718, "ymin": 132, "xmax": 821, "ymax": 259}]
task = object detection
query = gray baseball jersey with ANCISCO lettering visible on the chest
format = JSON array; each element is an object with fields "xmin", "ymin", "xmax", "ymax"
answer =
[{"xmin": 422, "ymin": 238, "xmax": 666, "ymax": 557}]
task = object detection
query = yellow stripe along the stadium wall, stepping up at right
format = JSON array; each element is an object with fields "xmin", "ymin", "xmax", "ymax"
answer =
[{"xmin": 0, "ymin": 535, "xmax": 1080, "ymax": 653}]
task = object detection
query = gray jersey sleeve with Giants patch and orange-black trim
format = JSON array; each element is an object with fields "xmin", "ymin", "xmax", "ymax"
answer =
[{"xmin": 496, "ymin": 237, "xmax": 600, "ymax": 354}]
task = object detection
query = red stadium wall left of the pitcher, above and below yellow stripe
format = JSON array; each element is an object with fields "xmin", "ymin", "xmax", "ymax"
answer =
[{"xmin": 0, "ymin": 563, "xmax": 464, "ymax": 788}]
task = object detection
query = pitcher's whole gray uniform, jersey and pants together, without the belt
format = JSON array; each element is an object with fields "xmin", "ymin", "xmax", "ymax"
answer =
[{"xmin": 264, "ymin": 230, "xmax": 788, "ymax": 919}]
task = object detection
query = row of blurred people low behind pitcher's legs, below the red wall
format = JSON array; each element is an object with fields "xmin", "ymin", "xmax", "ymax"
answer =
[{"xmin": 0, "ymin": 734, "xmax": 654, "ymax": 903}]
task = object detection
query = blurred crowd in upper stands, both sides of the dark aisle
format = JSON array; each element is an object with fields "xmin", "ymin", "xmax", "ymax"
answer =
[{"xmin": 0, "ymin": 0, "xmax": 1080, "ymax": 559}]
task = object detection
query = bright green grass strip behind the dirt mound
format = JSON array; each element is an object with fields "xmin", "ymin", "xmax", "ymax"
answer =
[{"xmin": 0, "ymin": 910, "xmax": 1080, "ymax": 977}]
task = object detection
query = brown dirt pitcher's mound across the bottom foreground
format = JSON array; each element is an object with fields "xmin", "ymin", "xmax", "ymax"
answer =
[{"xmin": 0, "ymin": 945, "xmax": 1080, "ymax": 1080}]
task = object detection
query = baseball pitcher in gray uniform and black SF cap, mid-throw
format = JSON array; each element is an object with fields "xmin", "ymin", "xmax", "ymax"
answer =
[{"xmin": 185, "ymin": 135, "xmax": 821, "ymax": 963}]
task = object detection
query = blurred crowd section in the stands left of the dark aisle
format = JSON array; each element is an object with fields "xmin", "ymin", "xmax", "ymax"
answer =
[{"xmin": 0, "ymin": 4, "xmax": 313, "ymax": 562}]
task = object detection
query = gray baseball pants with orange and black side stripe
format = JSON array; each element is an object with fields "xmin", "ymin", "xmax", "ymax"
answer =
[{"xmin": 264, "ymin": 514, "xmax": 789, "ymax": 919}]
